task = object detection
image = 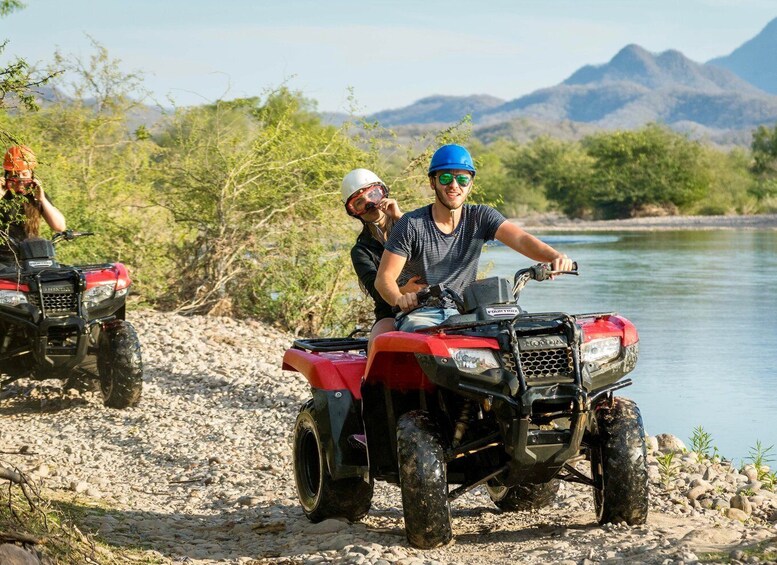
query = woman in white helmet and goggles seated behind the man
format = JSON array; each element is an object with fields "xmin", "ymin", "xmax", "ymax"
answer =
[{"xmin": 341, "ymin": 169, "xmax": 426, "ymax": 347}]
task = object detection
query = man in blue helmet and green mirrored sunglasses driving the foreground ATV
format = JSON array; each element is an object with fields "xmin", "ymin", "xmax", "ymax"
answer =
[{"xmin": 375, "ymin": 145, "xmax": 572, "ymax": 331}]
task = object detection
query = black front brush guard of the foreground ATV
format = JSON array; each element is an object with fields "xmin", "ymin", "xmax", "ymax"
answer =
[{"xmin": 416, "ymin": 313, "xmax": 631, "ymax": 492}]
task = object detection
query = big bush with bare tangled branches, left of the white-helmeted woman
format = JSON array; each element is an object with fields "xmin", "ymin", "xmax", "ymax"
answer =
[{"xmin": 155, "ymin": 88, "xmax": 371, "ymax": 334}]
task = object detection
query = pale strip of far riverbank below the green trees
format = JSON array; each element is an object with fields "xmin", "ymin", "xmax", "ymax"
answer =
[{"xmin": 511, "ymin": 214, "xmax": 777, "ymax": 232}]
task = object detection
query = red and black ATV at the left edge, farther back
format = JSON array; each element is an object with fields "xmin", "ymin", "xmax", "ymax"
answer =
[{"xmin": 0, "ymin": 230, "xmax": 143, "ymax": 408}]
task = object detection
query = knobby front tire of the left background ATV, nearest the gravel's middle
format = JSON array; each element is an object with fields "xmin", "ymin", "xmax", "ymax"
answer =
[{"xmin": 97, "ymin": 320, "xmax": 143, "ymax": 408}]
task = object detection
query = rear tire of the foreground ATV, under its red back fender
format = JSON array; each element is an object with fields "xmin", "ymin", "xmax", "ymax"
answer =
[{"xmin": 294, "ymin": 400, "xmax": 373, "ymax": 522}]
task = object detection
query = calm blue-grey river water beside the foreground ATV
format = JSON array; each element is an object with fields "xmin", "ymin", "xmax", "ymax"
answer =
[{"xmin": 480, "ymin": 231, "xmax": 777, "ymax": 466}]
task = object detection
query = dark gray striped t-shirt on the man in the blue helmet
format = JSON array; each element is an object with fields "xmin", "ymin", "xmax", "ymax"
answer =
[{"xmin": 385, "ymin": 204, "xmax": 505, "ymax": 296}]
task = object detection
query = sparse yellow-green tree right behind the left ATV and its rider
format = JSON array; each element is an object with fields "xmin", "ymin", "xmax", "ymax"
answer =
[{"xmin": 0, "ymin": 44, "xmax": 170, "ymax": 302}]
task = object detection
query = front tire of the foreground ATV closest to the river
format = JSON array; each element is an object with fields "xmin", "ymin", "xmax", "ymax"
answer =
[{"xmin": 591, "ymin": 397, "xmax": 648, "ymax": 526}]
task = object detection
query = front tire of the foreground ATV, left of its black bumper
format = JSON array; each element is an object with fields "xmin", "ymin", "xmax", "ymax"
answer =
[{"xmin": 397, "ymin": 410, "xmax": 453, "ymax": 549}]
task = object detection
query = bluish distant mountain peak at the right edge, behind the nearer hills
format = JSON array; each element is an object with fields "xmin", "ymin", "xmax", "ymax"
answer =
[{"xmin": 707, "ymin": 18, "xmax": 777, "ymax": 94}]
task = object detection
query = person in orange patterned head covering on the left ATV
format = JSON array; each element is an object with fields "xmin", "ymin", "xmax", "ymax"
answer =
[{"xmin": 0, "ymin": 145, "xmax": 67, "ymax": 263}]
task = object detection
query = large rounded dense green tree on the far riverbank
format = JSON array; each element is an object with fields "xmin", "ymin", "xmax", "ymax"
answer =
[{"xmin": 583, "ymin": 124, "xmax": 710, "ymax": 217}]
